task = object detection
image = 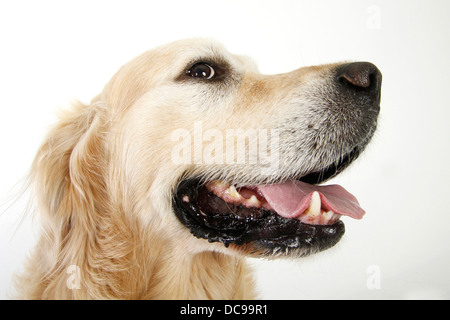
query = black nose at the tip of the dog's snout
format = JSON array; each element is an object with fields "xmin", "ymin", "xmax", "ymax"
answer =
[{"xmin": 337, "ymin": 62, "xmax": 381, "ymax": 95}]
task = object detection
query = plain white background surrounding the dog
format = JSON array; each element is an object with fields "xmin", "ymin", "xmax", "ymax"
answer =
[{"xmin": 0, "ymin": 0, "xmax": 450, "ymax": 299}]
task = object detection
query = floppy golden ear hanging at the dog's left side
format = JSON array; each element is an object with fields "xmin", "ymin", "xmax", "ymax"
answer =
[{"xmin": 31, "ymin": 103, "xmax": 105, "ymax": 227}]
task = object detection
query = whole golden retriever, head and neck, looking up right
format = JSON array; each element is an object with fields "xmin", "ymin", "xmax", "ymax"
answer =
[{"xmin": 17, "ymin": 39, "xmax": 381, "ymax": 299}]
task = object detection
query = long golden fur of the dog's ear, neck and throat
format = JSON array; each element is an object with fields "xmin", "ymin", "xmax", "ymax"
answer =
[{"xmin": 18, "ymin": 99, "xmax": 252, "ymax": 299}]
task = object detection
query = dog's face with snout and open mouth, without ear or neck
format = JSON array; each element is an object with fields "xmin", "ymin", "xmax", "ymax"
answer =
[{"xmin": 97, "ymin": 40, "xmax": 381, "ymax": 256}]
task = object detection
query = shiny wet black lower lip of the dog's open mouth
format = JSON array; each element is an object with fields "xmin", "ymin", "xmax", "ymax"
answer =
[{"xmin": 173, "ymin": 179, "xmax": 345, "ymax": 255}]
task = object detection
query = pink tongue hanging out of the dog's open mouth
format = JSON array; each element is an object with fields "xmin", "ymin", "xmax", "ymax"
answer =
[{"xmin": 257, "ymin": 180, "xmax": 365, "ymax": 219}]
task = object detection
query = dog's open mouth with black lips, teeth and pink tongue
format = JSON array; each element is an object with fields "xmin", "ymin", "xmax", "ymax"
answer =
[{"xmin": 173, "ymin": 148, "xmax": 365, "ymax": 256}]
